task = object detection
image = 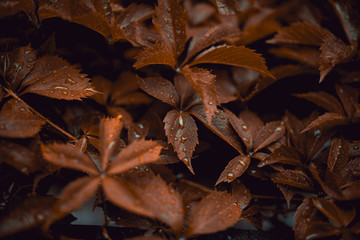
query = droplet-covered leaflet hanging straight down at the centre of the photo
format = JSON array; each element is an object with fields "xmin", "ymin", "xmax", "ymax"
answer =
[{"xmin": 164, "ymin": 110, "xmax": 199, "ymax": 173}]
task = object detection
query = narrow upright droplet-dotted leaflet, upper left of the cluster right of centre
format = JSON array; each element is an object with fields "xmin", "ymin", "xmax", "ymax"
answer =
[{"xmin": 225, "ymin": 109, "xmax": 254, "ymax": 152}]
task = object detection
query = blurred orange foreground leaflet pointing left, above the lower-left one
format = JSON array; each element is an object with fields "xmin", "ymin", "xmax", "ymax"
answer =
[{"xmin": 41, "ymin": 143, "xmax": 99, "ymax": 175}]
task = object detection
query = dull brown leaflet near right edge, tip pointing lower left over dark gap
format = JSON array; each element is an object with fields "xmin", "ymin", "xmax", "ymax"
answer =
[{"xmin": 301, "ymin": 112, "xmax": 347, "ymax": 133}]
